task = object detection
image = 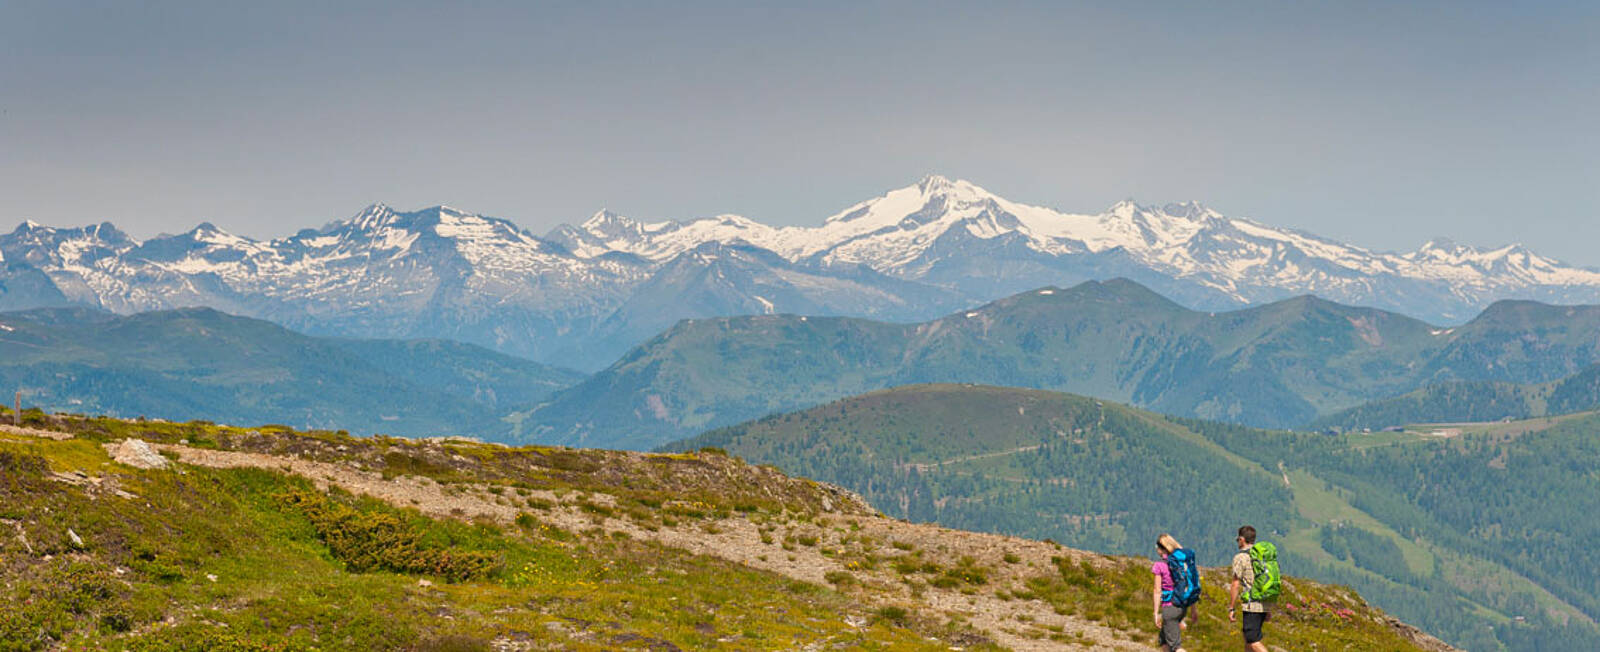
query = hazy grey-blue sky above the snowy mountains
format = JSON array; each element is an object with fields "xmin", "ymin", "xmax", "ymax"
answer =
[{"xmin": 0, "ymin": 0, "xmax": 1600, "ymax": 265}]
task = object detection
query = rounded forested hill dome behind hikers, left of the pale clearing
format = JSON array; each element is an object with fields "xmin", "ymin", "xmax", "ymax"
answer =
[{"xmin": 674, "ymin": 385, "xmax": 1293, "ymax": 566}]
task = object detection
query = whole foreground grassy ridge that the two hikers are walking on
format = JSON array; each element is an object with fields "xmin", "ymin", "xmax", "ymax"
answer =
[{"xmin": 0, "ymin": 407, "xmax": 1422, "ymax": 650}]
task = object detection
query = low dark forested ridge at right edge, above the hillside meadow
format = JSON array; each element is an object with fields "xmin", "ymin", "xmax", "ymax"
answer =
[{"xmin": 1312, "ymin": 366, "xmax": 1600, "ymax": 430}]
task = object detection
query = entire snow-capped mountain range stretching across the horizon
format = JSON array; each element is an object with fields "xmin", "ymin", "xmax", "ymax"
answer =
[{"xmin": 0, "ymin": 176, "xmax": 1600, "ymax": 369}]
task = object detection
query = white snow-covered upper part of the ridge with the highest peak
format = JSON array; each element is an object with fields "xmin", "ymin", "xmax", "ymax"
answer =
[{"xmin": 534, "ymin": 174, "xmax": 1600, "ymax": 304}]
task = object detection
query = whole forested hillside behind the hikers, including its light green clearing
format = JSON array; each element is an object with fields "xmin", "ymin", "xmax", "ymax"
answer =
[{"xmin": 672, "ymin": 385, "xmax": 1600, "ymax": 650}]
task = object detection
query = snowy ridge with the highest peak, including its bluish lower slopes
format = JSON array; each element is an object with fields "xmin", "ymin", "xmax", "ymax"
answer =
[{"xmin": 547, "ymin": 176, "xmax": 1600, "ymax": 323}]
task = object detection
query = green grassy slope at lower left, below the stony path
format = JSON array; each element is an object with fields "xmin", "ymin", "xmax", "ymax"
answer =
[{"xmin": 0, "ymin": 415, "xmax": 936, "ymax": 649}]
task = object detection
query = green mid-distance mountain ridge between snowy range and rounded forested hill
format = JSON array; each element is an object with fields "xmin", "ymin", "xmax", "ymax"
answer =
[{"xmin": 518, "ymin": 280, "xmax": 1600, "ymax": 447}]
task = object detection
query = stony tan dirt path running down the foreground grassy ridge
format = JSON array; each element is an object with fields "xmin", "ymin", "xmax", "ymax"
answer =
[{"xmin": 158, "ymin": 444, "xmax": 1149, "ymax": 650}]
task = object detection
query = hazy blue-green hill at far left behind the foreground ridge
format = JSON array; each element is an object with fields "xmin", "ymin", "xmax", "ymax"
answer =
[{"xmin": 0, "ymin": 308, "xmax": 578, "ymax": 436}]
